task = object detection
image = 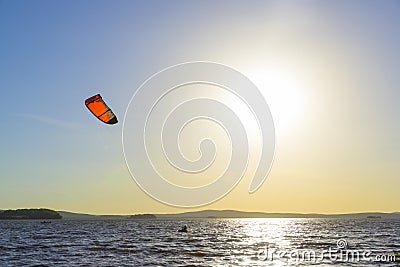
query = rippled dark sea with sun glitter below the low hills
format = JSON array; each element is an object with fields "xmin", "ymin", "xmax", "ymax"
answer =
[{"xmin": 0, "ymin": 218, "xmax": 400, "ymax": 266}]
